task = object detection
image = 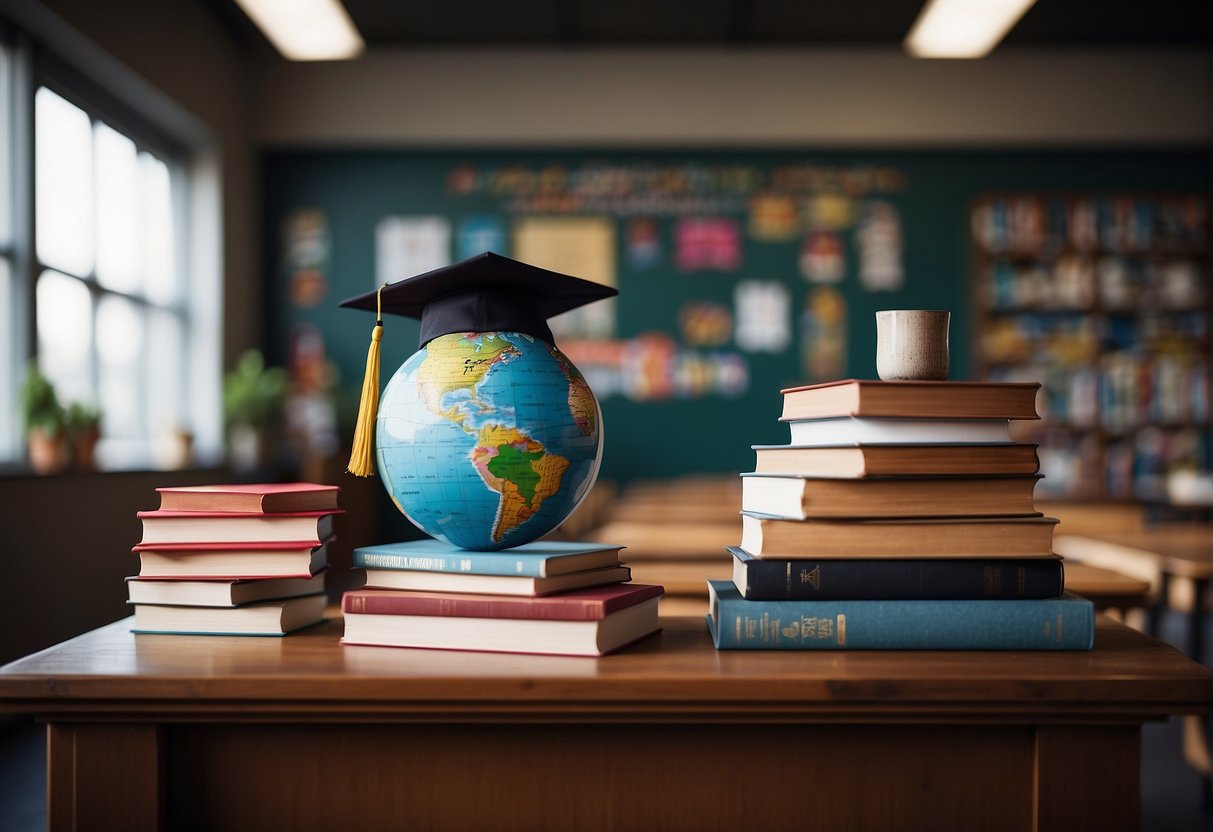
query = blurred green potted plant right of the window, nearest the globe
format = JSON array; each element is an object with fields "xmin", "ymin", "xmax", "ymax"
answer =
[{"xmin": 223, "ymin": 349, "xmax": 287, "ymax": 471}]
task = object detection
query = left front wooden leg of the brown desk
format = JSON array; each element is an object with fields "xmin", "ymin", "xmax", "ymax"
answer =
[{"xmin": 46, "ymin": 723, "xmax": 165, "ymax": 832}]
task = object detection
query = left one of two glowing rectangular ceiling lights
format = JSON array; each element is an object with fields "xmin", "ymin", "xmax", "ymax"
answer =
[{"xmin": 235, "ymin": 0, "xmax": 365, "ymax": 61}]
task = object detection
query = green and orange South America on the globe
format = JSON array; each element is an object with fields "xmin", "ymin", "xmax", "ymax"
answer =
[{"xmin": 471, "ymin": 424, "xmax": 569, "ymax": 542}]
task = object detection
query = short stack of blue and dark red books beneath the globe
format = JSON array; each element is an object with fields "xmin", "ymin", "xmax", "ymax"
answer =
[{"xmin": 341, "ymin": 540, "xmax": 664, "ymax": 656}]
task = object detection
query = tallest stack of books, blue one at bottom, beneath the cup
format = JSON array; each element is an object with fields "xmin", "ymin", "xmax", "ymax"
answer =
[{"xmin": 708, "ymin": 380, "xmax": 1094, "ymax": 650}]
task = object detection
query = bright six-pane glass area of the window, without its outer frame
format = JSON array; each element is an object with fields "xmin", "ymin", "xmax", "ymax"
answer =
[{"xmin": 34, "ymin": 86, "xmax": 188, "ymax": 468}]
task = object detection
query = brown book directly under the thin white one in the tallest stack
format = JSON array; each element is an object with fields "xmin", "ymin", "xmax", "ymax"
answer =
[{"xmin": 752, "ymin": 444, "xmax": 1041, "ymax": 478}]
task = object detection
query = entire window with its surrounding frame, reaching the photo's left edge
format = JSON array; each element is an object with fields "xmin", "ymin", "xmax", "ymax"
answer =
[{"xmin": 0, "ymin": 21, "xmax": 222, "ymax": 469}]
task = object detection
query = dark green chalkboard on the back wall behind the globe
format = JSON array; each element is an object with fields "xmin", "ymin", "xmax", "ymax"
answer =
[{"xmin": 263, "ymin": 149, "xmax": 1209, "ymax": 481}]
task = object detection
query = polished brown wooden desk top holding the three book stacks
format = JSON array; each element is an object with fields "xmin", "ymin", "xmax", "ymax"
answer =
[{"xmin": 0, "ymin": 617, "xmax": 1209, "ymax": 723}]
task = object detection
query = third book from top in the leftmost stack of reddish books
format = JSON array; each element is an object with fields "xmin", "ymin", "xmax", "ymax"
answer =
[{"xmin": 135, "ymin": 540, "xmax": 329, "ymax": 580}]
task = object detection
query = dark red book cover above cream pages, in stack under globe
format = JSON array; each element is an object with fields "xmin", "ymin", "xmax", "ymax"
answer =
[{"xmin": 341, "ymin": 583, "xmax": 665, "ymax": 621}]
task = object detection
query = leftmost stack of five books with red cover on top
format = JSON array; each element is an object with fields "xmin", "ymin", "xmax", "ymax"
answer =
[{"xmin": 126, "ymin": 483, "xmax": 341, "ymax": 636}]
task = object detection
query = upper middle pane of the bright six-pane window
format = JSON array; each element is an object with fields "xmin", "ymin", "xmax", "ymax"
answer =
[{"xmin": 93, "ymin": 124, "xmax": 139, "ymax": 292}]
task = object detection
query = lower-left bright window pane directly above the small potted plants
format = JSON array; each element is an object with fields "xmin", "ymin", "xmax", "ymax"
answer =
[{"xmin": 35, "ymin": 272, "xmax": 93, "ymax": 404}]
